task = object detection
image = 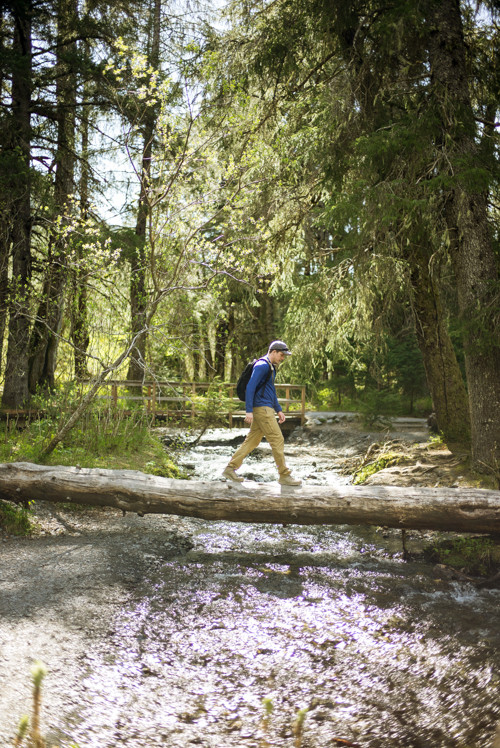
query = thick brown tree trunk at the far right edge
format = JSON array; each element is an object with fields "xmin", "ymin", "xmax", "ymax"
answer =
[{"xmin": 429, "ymin": 0, "xmax": 500, "ymax": 470}]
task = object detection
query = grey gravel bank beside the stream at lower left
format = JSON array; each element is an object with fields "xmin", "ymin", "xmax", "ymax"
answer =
[{"xmin": 0, "ymin": 504, "xmax": 190, "ymax": 746}]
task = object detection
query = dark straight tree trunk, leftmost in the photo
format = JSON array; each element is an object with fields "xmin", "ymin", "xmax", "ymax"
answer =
[{"xmin": 2, "ymin": 2, "xmax": 32, "ymax": 408}]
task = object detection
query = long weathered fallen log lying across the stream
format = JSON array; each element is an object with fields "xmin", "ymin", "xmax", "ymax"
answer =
[{"xmin": 0, "ymin": 462, "xmax": 500, "ymax": 535}]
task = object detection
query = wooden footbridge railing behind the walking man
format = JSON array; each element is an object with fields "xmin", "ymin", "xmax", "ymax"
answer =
[{"xmin": 81, "ymin": 379, "xmax": 306, "ymax": 427}]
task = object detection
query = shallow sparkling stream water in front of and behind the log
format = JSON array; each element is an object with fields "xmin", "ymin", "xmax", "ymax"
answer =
[{"xmin": 2, "ymin": 424, "xmax": 500, "ymax": 748}]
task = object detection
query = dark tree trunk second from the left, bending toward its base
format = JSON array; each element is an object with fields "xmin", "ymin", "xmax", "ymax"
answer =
[{"xmin": 29, "ymin": 0, "xmax": 77, "ymax": 393}]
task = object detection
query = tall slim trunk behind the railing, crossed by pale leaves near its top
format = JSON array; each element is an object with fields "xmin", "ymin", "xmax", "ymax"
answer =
[{"xmin": 127, "ymin": 0, "xmax": 162, "ymax": 381}]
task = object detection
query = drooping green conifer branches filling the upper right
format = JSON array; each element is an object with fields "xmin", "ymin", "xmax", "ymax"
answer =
[{"xmin": 203, "ymin": 0, "xmax": 498, "ymax": 470}]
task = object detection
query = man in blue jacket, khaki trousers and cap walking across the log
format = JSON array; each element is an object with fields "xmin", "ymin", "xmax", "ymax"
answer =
[{"xmin": 222, "ymin": 340, "xmax": 302, "ymax": 486}]
